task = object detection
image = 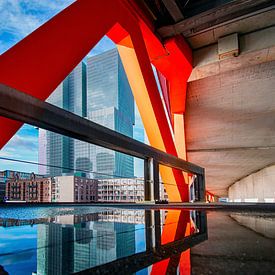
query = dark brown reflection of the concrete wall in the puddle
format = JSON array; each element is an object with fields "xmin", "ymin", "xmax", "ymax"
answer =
[{"xmin": 191, "ymin": 212, "xmax": 275, "ymax": 275}]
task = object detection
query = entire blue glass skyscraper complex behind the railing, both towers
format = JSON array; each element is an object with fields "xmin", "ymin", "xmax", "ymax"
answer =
[{"xmin": 39, "ymin": 49, "xmax": 135, "ymax": 178}]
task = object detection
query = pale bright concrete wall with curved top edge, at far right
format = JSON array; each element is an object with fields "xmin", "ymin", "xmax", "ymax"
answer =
[{"xmin": 228, "ymin": 165, "xmax": 275, "ymax": 202}]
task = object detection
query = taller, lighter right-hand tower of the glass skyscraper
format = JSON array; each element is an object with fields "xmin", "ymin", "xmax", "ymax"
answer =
[{"xmin": 74, "ymin": 49, "xmax": 135, "ymax": 178}]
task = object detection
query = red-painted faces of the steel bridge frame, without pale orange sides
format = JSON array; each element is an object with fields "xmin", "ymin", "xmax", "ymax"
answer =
[{"xmin": 0, "ymin": 0, "xmax": 194, "ymax": 203}]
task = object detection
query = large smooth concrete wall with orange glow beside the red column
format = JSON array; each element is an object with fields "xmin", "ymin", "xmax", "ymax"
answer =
[{"xmin": 185, "ymin": 61, "xmax": 275, "ymax": 196}]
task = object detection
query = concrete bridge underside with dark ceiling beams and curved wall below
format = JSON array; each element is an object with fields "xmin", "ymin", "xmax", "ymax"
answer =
[{"xmin": 139, "ymin": 0, "xmax": 275, "ymax": 199}]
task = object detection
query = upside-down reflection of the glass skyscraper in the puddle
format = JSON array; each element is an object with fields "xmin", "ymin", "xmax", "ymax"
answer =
[{"xmin": 37, "ymin": 213, "xmax": 135, "ymax": 275}]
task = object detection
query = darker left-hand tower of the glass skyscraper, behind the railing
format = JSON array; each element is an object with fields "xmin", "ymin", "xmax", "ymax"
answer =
[{"xmin": 39, "ymin": 62, "xmax": 87, "ymax": 176}]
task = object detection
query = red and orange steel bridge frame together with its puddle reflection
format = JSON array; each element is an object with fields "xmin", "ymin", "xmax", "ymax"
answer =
[{"xmin": 0, "ymin": 0, "xmax": 195, "ymax": 273}]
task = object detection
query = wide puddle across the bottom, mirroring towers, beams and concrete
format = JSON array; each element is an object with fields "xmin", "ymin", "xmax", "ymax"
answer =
[{"xmin": 0, "ymin": 208, "xmax": 275, "ymax": 275}]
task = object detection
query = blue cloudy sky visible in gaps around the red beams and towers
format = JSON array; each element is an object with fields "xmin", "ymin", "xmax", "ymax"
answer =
[{"xmin": 0, "ymin": 0, "xmax": 144, "ymax": 175}]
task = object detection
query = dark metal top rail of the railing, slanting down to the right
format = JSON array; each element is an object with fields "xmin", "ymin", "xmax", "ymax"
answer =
[{"xmin": 0, "ymin": 84, "xmax": 204, "ymax": 174}]
